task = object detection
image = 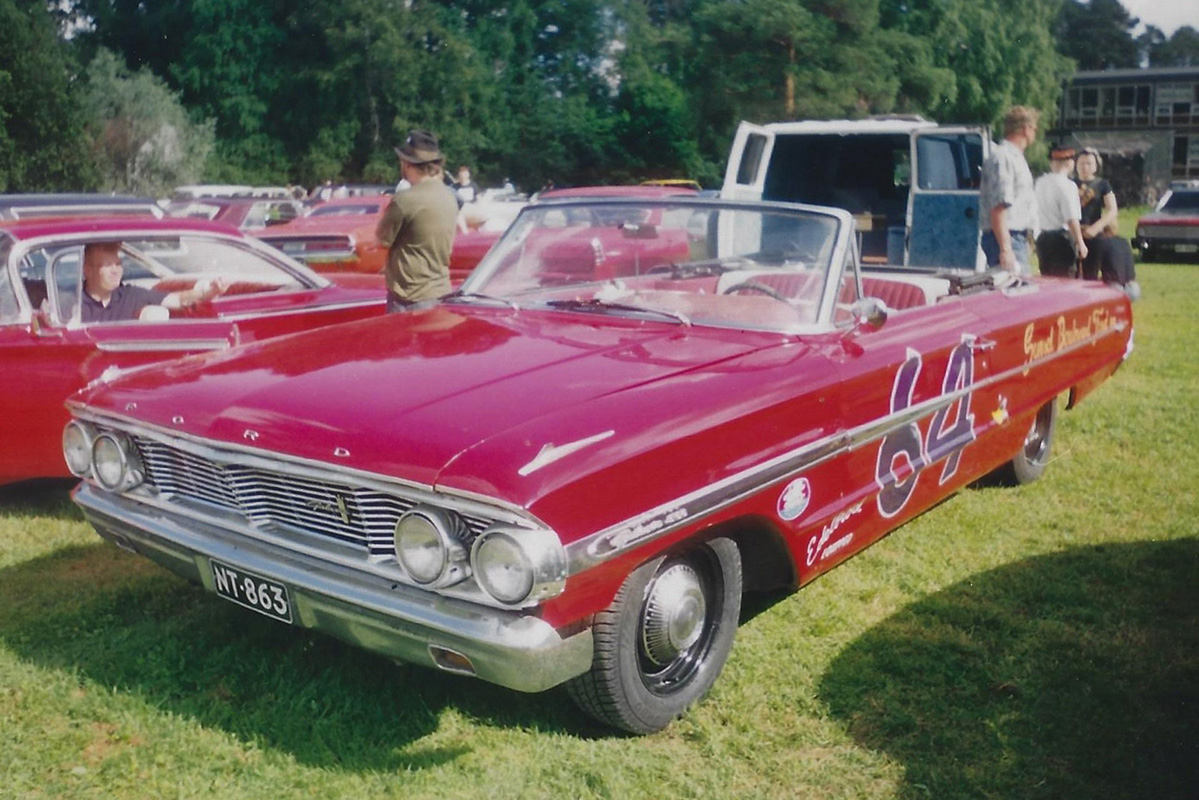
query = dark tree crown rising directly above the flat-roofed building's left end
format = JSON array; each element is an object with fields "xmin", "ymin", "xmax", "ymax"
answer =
[{"xmin": 1053, "ymin": 0, "xmax": 1140, "ymax": 70}]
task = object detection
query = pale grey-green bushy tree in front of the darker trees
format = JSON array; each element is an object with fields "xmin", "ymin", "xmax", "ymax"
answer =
[{"xmin": 83, "ymin": 49, "xmax": 213, "ymax": 196}]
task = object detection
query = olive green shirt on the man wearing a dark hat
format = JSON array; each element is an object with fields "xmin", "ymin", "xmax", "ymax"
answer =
[{"xmin": 375, "ymin": 178, "xmax": 458, "ymax": 302}]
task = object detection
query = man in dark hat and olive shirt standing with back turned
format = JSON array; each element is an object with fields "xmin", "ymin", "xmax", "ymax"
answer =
[{"xmin": 375, "ymin": 131, "xmax": 458, "ymax": 312}]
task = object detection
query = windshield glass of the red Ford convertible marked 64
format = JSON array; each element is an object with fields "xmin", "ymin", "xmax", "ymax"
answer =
[{"xmin": 458, "ymin": 199, "xmax": 848, "ymax": 331}]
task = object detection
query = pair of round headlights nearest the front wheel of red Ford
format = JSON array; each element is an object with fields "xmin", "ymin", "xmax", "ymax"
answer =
[{"xmin": 396, "ymin": 506, "xmax": 566, "ymax": 606}]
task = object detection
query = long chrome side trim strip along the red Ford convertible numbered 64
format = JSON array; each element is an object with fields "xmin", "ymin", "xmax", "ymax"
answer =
[{"xmin": 566, "ymin": 316, "xmax": 1125, "ymax": 575}]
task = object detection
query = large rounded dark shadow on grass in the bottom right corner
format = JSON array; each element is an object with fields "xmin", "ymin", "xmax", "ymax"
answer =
[{"xmin": 820, "ymin": 540, "xmax": 1199, "ymax": 800}]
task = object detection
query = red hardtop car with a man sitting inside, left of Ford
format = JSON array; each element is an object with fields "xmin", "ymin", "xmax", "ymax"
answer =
[{"xmin": 0, "ymin": 217, "xmax": 384, "ymax": 483}]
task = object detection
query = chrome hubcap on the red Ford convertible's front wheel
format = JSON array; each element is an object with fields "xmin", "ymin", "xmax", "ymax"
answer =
[{"xmin": 641, "ymin": 564, "xmax": 707, "ymax": 667}]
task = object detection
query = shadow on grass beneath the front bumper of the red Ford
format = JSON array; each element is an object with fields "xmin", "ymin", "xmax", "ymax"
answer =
[{"xmin": 0, "ymin": 542, "xmax": 585, "ymax": 771}]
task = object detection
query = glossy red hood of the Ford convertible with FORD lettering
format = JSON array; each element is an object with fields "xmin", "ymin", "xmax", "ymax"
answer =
[{"xmin": 78, "ymin": 306, "xmax": 787, "ymax": 491}]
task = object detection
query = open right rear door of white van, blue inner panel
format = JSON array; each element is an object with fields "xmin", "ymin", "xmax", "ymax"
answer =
[{"xmin": 904, "ymin": 127, "xmax": 990, "ymax": 269}]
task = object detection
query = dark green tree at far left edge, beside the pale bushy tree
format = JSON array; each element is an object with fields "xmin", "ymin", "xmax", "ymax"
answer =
[{"xmin": 0, "ymin": 0, "xmax": 95, "ymax": 192}]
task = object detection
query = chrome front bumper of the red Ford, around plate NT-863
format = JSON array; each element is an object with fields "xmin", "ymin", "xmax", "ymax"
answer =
[{"xmin": 73, "ymin": 483, "xmax": 592, "ymax": 692}]
